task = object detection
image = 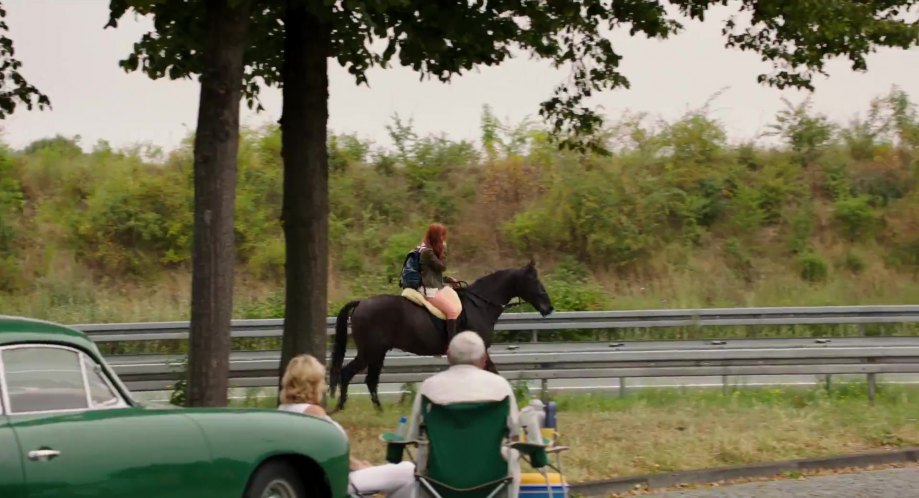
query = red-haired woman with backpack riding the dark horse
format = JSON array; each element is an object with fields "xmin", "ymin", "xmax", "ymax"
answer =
[{"xmin": 420, "ymin": 223, "xmax": 462, "ymax": 341}]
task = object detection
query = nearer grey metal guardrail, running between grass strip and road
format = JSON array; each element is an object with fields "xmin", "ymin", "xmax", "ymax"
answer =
[{"xmin": 108, "ymin": 337, "xmax": 919, "ymax": 398}]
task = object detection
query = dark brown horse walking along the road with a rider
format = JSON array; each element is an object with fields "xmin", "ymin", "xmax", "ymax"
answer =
[{"xmin": 329, "ymin": 261, "xmax": 554, "ymax": 410}]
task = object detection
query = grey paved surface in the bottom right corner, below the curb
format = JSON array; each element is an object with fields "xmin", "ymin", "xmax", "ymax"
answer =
[{"xmin": 649, "ymin": 467, "xmax": 919, "ymax": 498}]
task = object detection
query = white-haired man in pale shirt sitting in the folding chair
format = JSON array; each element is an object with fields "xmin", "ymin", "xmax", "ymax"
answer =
[{"xmin": 408, "ymin": 331, "xmax": 541, "ymax": 496}]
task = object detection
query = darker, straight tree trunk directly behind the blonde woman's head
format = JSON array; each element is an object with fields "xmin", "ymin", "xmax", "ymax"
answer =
[{"xmin": 280, "ymin": 0, "xmax": 329, "ymax": 396}]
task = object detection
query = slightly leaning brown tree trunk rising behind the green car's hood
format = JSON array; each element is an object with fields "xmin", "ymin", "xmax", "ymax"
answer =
[{"xmin": 186, "ymin": 0, "xmax": 250, "ymax": 406}]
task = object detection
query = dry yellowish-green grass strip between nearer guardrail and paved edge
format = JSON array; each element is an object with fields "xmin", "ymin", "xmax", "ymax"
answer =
[{"xmin": 244, "ymin": 383, "xmax": 919, "ymax": 482}]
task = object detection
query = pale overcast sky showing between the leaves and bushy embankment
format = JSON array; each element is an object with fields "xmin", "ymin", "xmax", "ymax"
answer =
[{"xmin": 0, "ymin": 0, "xmax": 919, "ymax": 154}]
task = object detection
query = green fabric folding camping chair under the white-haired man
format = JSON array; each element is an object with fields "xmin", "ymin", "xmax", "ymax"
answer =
[{"xmin": 383, "ymin": 396, "xmax": 568, "ymax": 498}]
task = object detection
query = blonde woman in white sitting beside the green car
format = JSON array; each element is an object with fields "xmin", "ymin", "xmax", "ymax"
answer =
[{"xmin": 278, "ymin": 354, "xmax": 415, "ymax": 498}]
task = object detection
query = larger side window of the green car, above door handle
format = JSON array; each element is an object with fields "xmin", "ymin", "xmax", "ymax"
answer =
[{"xmin": 2, "ymin": 347, "xmax": 89, "ymax": 413}]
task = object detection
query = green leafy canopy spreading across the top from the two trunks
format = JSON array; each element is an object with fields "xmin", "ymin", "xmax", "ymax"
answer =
[{"xmin": 109, "ymin": 0, "xmax": 919, "ymax": 151}]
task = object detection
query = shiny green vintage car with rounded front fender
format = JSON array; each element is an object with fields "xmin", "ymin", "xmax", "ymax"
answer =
[{"xmin": 0, "ymin": 316, "xmax": 349, "ymax": 498}]
